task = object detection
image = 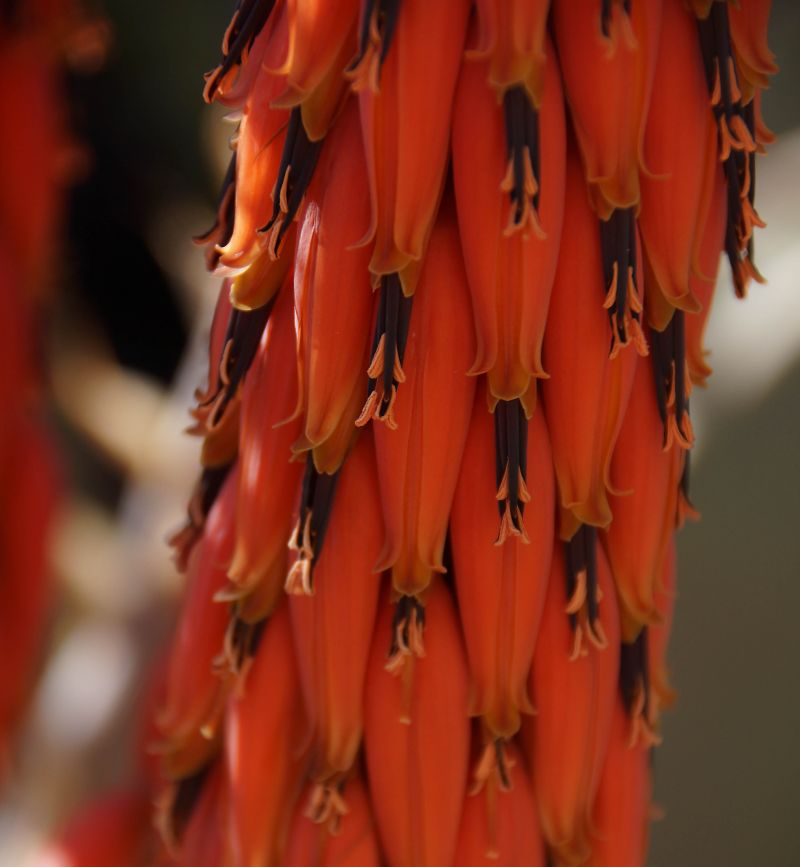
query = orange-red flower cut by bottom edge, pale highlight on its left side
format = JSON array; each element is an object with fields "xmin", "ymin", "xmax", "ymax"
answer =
[{"xmin": 225, "ymin": 604, "xmax": 305, "ymax": 867}]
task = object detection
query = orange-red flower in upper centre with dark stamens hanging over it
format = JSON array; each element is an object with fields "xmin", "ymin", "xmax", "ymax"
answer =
[{"xmin": 453, "ymin": 39, "xmax": 565, "ymax": 408}]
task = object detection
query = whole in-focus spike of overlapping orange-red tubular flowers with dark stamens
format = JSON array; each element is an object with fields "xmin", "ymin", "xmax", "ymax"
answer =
[{"xmin": 45, "ymin": 0, "xmax": 775, "ymax": 867}]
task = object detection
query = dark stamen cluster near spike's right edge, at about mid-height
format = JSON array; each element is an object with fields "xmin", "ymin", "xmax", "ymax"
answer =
[{"xmin": 650, "ymin": 310, "xmax": 693, "ymax": 448}]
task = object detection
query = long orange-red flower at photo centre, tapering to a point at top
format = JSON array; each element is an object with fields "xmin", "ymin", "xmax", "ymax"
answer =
[{"xmin": 373, "ymin": 203, "xmax": 475, "ymax": 595}]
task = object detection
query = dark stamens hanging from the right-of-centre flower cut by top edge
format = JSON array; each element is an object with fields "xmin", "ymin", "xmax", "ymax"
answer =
[{"xmin": 600, "ymin": 208, "xmax": 644, "ymax": 356}]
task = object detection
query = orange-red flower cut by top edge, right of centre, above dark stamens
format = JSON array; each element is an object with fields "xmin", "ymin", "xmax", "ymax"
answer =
[{"xmin": 553, "ymin": 0, "xmax": 662, "ymax": 219}]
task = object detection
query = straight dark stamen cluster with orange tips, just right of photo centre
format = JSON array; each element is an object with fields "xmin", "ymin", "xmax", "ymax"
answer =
[{"xmin": 494, "ymin": 400, "xmax": 530, "ymax": 543}]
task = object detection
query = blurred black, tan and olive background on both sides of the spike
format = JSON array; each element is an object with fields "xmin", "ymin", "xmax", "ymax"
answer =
[{"xmin": 0, "ymin": 0, "xmax": 800, "ymax": 867}]
